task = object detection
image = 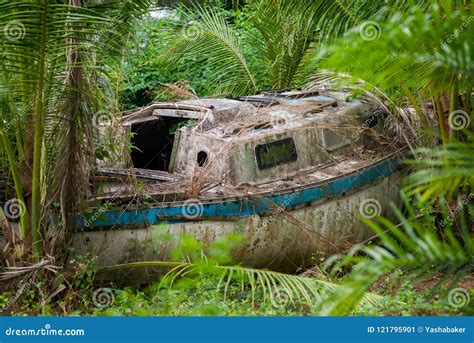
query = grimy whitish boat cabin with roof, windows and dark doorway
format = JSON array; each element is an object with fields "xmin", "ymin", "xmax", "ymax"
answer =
[{"xmin": 98, "ymin": 91, "xmax": 379, "ymax": 194}]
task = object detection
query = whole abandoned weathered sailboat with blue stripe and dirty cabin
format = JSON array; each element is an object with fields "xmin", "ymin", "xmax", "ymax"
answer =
[{"xmin": 74, "ymin": 91, "xmax": 400, "ymax": 275}]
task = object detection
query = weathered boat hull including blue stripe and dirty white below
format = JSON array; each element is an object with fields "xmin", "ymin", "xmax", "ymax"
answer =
[{"xmin": 73, "ymin": 160, "xmax": 400, "ymax": 278}]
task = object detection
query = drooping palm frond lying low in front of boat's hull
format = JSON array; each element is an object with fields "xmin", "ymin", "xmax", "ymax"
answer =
[{"xmin": 98, "ymin": 256, "xmax": 381, "ymax": 312}]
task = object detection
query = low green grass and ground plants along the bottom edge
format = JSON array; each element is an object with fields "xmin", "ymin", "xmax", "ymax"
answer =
[{"xmin": 0, "ymin": 272, "xmax": 474, "ymax": 316}]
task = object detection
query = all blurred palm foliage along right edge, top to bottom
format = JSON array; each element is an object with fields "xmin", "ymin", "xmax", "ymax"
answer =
[{"xmin": 310, "ymin": 1, "xmax": 474, "ymax": 314}]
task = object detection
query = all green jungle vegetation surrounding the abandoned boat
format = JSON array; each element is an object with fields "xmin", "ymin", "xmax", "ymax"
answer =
[{"xmin": 0, "ymin": 0, "xmax": 474, "ymax": 315}]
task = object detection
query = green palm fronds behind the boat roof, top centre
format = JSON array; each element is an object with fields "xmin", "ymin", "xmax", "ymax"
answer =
[{"xmin": 162, "ymin": 0, "xmax": 426, "ymax": 95}]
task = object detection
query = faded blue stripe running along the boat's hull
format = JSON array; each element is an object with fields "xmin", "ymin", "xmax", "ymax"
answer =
[{"xmin": 77, "ymin": 159, "xmax": 399, "ymax": 229}]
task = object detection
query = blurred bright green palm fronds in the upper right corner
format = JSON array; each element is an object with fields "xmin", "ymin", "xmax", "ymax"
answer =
[{"xmin": 321, "ymin": 0, "xmax": 474, "ymax": 143}]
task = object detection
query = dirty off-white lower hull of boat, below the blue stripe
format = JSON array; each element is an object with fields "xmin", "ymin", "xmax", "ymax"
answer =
[{"xmin": 73, "ymin": 172, "xmax": 400, "ymax": 278}]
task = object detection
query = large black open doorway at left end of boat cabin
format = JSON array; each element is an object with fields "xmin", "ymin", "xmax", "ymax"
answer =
[{"xmin": 131, "ymin": 117, "xmax": 193, "ymax": 172}]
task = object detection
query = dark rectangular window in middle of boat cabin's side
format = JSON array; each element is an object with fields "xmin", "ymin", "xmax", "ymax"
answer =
[{"xmin": 255, "ymin": 138, "xmax": 298, "ymax": 170}]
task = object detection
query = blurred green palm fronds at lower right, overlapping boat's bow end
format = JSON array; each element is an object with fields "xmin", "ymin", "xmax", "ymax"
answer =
[{"xmin": 323, "ymin": 194, "xmax": 474, "ymax": 315}]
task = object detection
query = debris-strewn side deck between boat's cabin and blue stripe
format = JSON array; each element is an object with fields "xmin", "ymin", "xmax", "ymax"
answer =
[{"xmin": 91, "ymin": 147, "xmax": 397, "ymax": 209}]
